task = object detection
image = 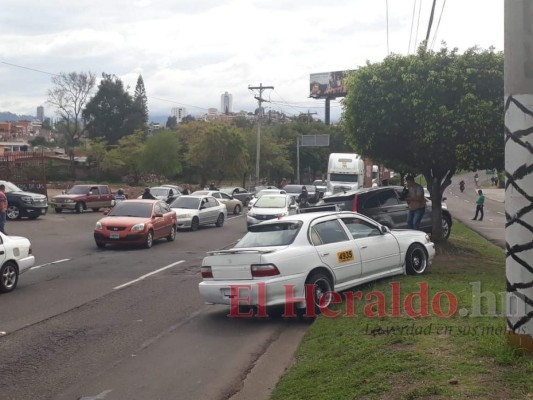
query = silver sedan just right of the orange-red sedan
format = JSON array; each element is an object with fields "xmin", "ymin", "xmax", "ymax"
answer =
[{"xmin": 170, "ymin": 195, "xmax": 228, "ymax": 231}]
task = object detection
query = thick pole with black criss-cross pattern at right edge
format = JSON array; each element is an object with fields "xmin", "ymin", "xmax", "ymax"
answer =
[{"xmin": 504, "ymin": 0, "xmax": 533, "ymax": 353}]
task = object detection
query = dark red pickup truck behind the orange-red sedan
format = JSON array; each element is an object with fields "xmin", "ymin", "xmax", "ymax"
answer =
[{"xmin": 50, "ymin": 185, "xmax": 113, "ymax": 213}]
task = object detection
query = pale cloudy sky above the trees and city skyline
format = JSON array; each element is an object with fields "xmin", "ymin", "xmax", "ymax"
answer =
[{"xmin": 0, "ymin": 0, "xmax": 504, "ymax": 119}]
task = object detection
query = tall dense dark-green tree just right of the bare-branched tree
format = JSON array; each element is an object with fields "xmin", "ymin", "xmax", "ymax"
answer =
[{"xmin": 83, "ymin": 73, "xmax": 136, "ymax": 145}]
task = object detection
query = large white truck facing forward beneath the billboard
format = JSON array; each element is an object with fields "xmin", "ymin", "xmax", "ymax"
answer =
[{"xmin": 327, "ymin": 153, "xmax": 365, "ymax": 194}]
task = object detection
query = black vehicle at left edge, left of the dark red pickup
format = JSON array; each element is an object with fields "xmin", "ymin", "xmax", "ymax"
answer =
[{"xmin": 0, "ymin": 181, "xmax": 48, "ymax": 220}]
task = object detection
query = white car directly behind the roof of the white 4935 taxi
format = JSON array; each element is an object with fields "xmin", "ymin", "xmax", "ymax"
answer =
[{"xmin": 246, "ymin": 193, "xmax": 298, "ymax": 226}]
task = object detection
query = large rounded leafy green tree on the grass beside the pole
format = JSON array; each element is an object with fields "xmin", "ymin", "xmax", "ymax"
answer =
[{"xmin": 343, "ymin": 46, "xmax": 504, "ymax": 240}]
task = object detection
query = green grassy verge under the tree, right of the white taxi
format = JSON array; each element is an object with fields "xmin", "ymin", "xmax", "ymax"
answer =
[{"xmin": 272, "ymin": 222, "xmax": 533, "ymax": 400}]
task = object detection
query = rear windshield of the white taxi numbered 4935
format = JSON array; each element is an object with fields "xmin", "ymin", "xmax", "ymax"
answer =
[{"xmin": 235, "ymin": 222, "xmax": 302, "ymax": 248}]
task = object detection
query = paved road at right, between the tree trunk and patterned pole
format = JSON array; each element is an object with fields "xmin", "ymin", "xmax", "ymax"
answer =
[{"xmin": 444, "ymin": 171, "xmax": 505, "ymax": 248}]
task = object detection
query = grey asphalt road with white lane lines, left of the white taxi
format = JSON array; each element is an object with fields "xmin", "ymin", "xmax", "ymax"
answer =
[{"xmin": 0, "ymin": 212, "xmax": 309, "ymax": 400}]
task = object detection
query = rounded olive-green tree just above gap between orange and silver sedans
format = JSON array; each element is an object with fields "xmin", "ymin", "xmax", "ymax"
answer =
[{"xmin": 142, "ymin": 130, "xmax": 182, "ymax": 178}]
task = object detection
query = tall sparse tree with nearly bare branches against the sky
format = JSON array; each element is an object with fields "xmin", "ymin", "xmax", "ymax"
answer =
[{"xmin": 47, "ymin": 72, "xmax": 96, "ymax": 174}]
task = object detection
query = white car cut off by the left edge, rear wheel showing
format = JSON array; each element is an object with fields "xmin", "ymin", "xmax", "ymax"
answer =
[{"xmin": 0, "ymin": 233, "xmax": 35, "ymax": 293}]
